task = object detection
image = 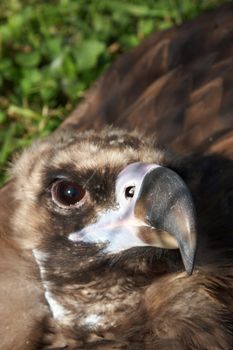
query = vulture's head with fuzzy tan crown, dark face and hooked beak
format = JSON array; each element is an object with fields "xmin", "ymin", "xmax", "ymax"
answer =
[{"xmin": 12, "ymin": 128, "xmax": 196, "ymax": 346}]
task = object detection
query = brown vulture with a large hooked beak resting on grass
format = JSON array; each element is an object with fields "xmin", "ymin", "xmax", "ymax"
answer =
[{"xmin": 0, "ymin": 3, "xmax": 233, "ymax": 350}]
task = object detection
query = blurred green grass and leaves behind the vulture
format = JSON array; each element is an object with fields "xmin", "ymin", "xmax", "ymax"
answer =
[{"xmin": 0, "ymin": 0, "xmax": 229, "ymax": 184}]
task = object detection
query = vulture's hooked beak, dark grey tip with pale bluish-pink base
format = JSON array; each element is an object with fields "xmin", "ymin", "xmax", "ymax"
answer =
[{"xmin": 69, "ymin": 163, "xmax": 196, "ymax": 275}]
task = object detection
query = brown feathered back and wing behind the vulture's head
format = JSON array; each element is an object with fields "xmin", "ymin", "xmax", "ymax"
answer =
[{"xmin": 63, "ymin": 3, "xmax": 233, "ymax": 154}]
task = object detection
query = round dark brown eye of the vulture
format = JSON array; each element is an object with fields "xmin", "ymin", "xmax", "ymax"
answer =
[{"xmin": 52, "ymin": 180, "xmax": 86, "ymax": 207}]
